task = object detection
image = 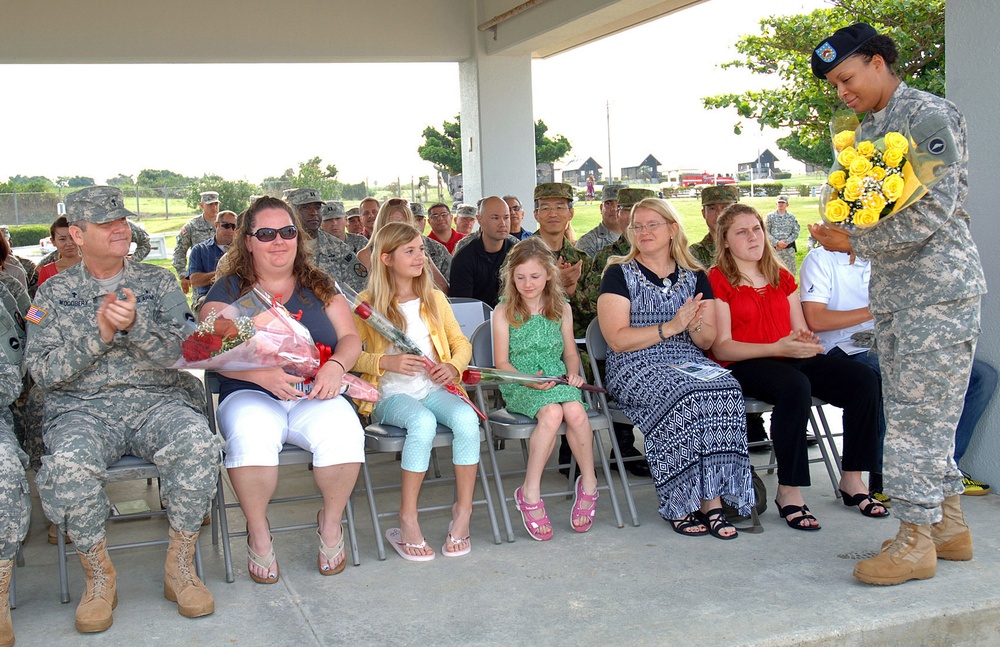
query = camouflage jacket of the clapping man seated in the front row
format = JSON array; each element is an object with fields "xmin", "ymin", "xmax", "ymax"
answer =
[{"xmin": 25, "ymin": 260, "xmax": 203, "ymax": 425}]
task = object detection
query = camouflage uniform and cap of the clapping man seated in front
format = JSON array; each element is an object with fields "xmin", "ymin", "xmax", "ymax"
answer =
[{"xmin": 26, "ymin": 187, "xmax": 220, "ymax": 552}]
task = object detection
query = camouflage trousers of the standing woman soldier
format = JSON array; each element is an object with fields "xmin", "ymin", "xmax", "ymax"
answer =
[{"xmin": 875, "ymin": 297, "xmax": 979, "ymax": 525}]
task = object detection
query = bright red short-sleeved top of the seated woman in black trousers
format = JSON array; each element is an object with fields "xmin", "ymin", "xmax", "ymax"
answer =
[{"xmin": 708, "ymin": 267, "xmax": 799, "ymax": 366}]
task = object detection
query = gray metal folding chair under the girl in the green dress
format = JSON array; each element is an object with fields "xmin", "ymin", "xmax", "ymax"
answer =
[{"xmin": 472, "ymin": 321, "xmax": 625, "ymax": 542}]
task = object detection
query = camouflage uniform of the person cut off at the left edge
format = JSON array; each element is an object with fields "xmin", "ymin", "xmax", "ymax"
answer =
[{"xmin": 0, "ymin": 290, "xmax": 31, "ymax": 560}]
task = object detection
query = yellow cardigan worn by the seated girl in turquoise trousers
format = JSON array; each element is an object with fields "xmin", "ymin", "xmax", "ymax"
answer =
[{"xmin": 352, "ymin": 290, "xmax": 472, "ymax": 416}]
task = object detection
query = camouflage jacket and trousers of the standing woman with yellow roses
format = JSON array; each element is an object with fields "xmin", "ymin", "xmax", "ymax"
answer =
[{"xmin": 851, "ymin": 83, "xmax": 986, "ymax": 525}]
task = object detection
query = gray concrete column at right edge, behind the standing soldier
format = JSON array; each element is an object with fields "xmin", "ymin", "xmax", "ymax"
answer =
[{"xmin": 945, "ymin": 0, "xmax": 1000, "ymax": 489}]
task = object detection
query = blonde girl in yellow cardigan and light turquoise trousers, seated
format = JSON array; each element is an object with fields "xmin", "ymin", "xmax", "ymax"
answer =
[{"xmin": 354, "ymin": 222, "xmax": 479, "ymax": 561}]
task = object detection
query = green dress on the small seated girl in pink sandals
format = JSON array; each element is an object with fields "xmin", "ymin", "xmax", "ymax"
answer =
[{"xmin": 500, "ymin": 315, "xmax": 583, "ymax": 418}]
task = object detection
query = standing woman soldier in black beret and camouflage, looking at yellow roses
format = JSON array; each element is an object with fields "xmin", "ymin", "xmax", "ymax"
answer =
[{"xmin": 810, "ymin": 23, "xmax": 986, "ymax": 584}]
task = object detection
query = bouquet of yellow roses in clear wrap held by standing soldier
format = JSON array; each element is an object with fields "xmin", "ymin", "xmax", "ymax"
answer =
[{"xmin": 820, "ymin": 113, "xmax": 940, "ymax": 233}]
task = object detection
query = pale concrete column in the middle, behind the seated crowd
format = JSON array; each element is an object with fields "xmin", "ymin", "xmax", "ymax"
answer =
[{"xmin": 459, "ymin": 41, "xmax": 535, "ymax": 229}]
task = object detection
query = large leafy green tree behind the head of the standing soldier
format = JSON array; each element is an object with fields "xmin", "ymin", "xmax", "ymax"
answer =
[{"xmin": 702, "ymin": 0, "xmax": 945, "ymax": 167}]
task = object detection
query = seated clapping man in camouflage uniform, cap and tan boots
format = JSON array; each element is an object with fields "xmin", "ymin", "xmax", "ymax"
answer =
[{"xmin": 25, "ymin": 186, "xmax": 220, "ymax": 633}]
